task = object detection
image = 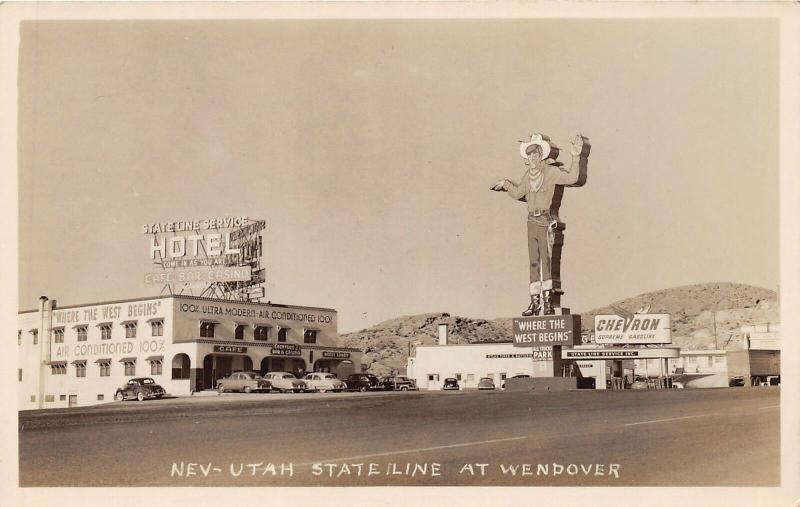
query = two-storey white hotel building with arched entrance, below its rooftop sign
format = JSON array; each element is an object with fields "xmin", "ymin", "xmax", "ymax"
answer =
[{"xmin": 17, "ymin": 295, "xmax": 362, "ymax": 410}]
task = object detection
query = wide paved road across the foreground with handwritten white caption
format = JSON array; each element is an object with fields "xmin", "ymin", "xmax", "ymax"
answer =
[{"xmin": 19, "ymin": 388, "xmax": 780, "ymax": 486}]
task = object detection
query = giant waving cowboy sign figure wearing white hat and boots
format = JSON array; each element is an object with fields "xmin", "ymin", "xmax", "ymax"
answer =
[{"xmin": 492, "ymin": 134, "xmax": 589, "ymax": 317}]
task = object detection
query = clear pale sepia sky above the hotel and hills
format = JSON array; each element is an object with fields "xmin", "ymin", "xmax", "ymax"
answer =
[{"xmin": 18, "ymin": 19, "xmax": 779, "ymax": 332}]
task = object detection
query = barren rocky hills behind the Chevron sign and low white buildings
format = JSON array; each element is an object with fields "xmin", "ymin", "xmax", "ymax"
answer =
[{"xmin": 340, "ymin": 283, "xmax": 780, "ymax": 375}]
